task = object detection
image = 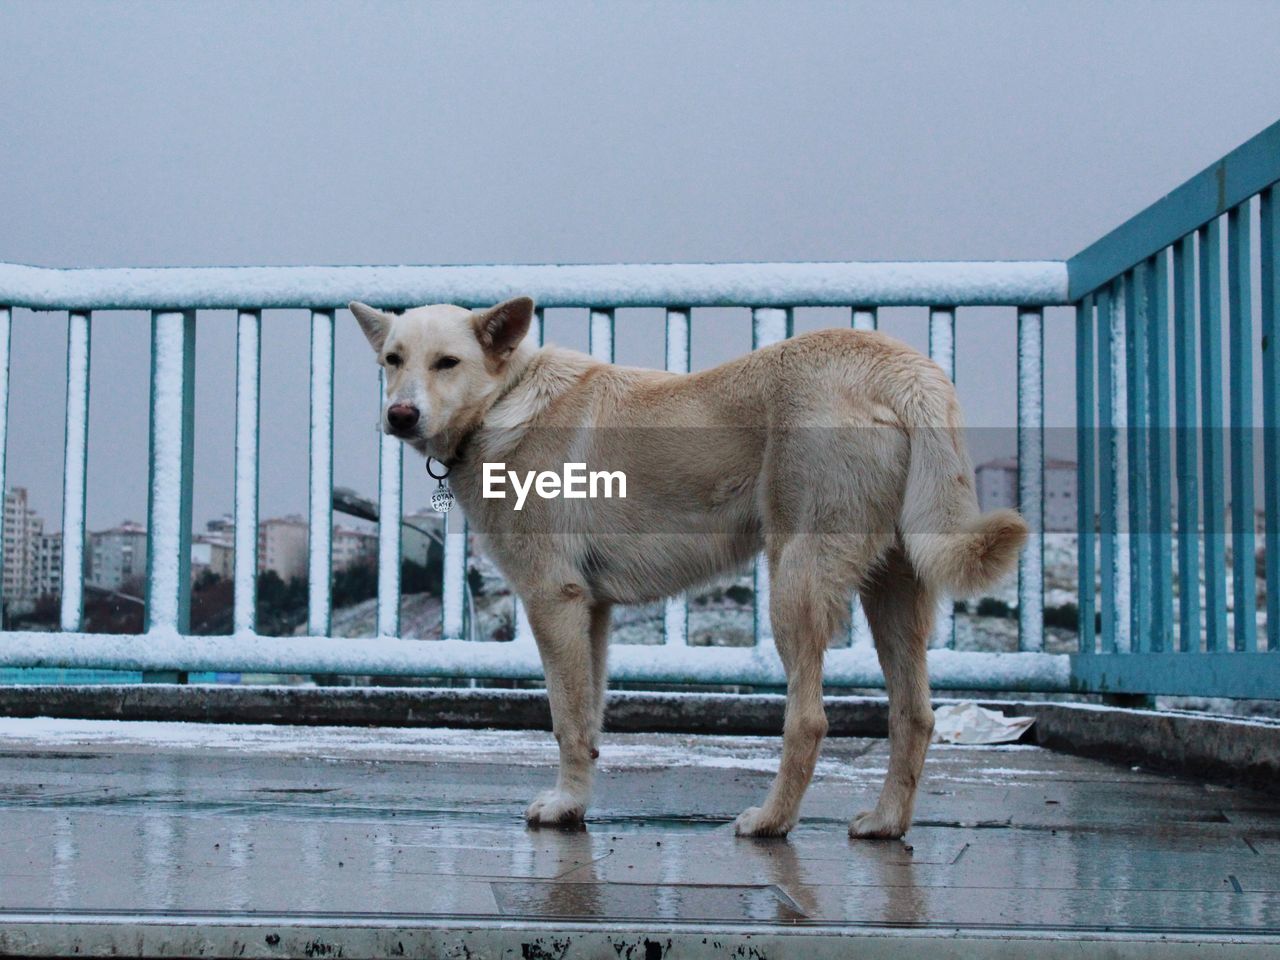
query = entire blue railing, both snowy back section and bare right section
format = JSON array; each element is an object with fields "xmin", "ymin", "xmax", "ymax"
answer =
[{"xmin": 0, "ymin": 118, "xmax": 1280, "ymax": 696}]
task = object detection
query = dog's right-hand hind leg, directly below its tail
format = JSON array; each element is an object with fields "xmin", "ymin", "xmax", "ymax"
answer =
[{"xmin": 849, "ymin": 545, "xmax": 936, "ymax": 837}]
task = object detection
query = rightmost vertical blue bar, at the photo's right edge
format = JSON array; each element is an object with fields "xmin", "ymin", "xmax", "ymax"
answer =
[{"xmin": 1259, "ymin": 187, "xmax": 1280, "ymax": 653}]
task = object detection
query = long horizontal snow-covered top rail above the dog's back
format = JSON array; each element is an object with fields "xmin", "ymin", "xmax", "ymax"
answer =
[{"xmin": 0, "ymin": 261, "xmax": 1069, "ymax": 310}]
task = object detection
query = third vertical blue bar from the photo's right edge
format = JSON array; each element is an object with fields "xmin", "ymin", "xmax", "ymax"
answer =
[{"xmin": 1198, "ymin": 218, "xmax": 1226, "ymax": 653}]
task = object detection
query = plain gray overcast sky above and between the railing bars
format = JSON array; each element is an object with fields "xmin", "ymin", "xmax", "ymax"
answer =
[{"xmin": 0, "ymin": 0, "xmax": 1280, "ymax": 527}]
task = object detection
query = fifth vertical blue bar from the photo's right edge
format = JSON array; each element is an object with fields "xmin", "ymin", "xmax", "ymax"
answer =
[{"xmin": 1152, "ymin": 250, "xmax": 1174, "ymax": 652}]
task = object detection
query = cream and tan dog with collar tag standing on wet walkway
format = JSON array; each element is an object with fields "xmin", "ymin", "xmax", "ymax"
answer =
[{"xmin": 351, "ymin": 297, "xmax": 1028, "ymax": 838}]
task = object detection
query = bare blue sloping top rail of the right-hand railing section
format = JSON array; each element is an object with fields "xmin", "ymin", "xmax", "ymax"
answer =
[{"xmin": 1066, "ymin": 120, "xmax": 1280, "ymax": 302}]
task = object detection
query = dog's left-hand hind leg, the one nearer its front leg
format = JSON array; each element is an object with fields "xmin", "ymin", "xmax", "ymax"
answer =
[{"xmin": 733, "ymin": 534, "xmax": 847, "ymax": 837}]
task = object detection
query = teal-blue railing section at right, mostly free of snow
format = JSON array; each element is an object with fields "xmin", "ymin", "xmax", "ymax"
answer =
[{"xmin": 1068, "ymin": 123, "xmax": 1280, "ymax": 698}]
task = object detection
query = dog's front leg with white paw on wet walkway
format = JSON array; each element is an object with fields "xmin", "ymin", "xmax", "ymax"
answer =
[{"xmin": 525, "ymin": 593, "xmax": 598, "ymax": 826}]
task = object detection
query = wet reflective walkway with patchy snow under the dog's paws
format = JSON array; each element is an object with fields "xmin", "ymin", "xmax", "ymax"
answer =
[{"xmin": 0, "ymin": 719, "xmax": 1280, "ymax": 960}]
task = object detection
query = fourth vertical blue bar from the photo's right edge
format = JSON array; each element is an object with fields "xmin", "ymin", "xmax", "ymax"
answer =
[{"xmin": 1174, "ymin": 234, "xmax": 1201, "ymax": 652}]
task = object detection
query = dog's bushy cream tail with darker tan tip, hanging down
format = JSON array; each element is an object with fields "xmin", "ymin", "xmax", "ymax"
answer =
[{"xmin": 899, "ymin": 365, "xmax": 1028, "ymax": 596}]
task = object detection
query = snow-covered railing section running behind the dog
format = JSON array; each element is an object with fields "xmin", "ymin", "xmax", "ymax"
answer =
[{"xmin": 0, "ymin": 262, "xmax": 1070, "ymax": 690}]
